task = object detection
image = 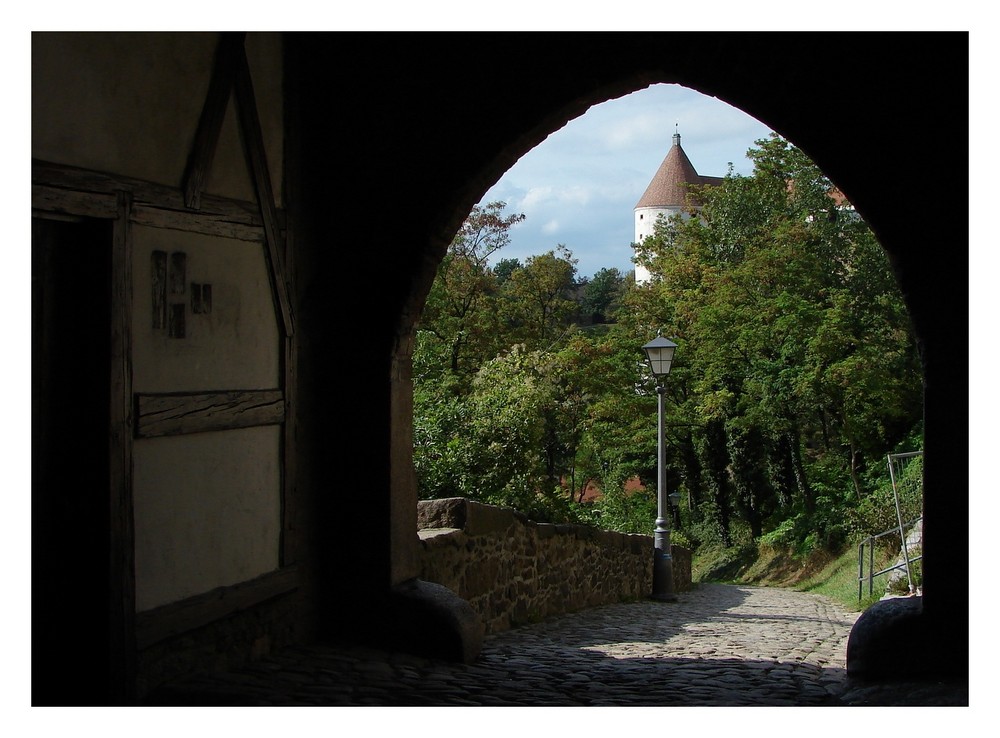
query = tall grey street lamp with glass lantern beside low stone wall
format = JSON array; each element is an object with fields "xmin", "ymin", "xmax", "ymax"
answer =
[{"xmin": 642, "ymin": 333, "xmax": 677, "ymax": 602}]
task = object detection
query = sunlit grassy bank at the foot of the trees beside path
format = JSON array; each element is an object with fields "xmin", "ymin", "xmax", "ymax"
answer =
[{"xmin": 691, "ymin": 543, "xmax": 891, "ymax": 612}]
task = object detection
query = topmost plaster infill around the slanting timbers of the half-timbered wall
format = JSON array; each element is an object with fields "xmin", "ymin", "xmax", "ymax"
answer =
[{"xmin": 31, "ymin": 32, "xmax": 283, "ymax": 203}]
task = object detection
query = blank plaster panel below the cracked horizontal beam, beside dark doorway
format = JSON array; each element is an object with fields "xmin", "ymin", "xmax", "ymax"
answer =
[{"xmin": 134, "ymin": 426, "xmax": 281, "ymax": 612}]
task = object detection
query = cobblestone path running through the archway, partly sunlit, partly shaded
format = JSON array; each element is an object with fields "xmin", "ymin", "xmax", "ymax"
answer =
[{"xmin": 148, "ymin": 584, "xmax": 961, "ymax": 706}]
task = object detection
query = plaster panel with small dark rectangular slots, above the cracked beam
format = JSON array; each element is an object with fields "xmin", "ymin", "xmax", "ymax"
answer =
[{"xmin": 132, "ymin": 226, "xmax": 281, "ymax": 392}]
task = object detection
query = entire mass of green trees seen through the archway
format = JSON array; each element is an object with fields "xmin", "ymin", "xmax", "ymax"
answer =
[{"xmin": 414, "ymin": 135, "xmax": 922, "ymax": 550}]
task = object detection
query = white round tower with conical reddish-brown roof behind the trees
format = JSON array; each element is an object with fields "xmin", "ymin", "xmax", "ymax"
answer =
[{"xmin": 634, "ymin": 132, "xmax": 722, "ymax": 284}]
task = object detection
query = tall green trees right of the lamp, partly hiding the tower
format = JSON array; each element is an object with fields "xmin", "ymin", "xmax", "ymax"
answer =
[{"xmin": 636, "ymin": 132, "xmax": 921, "ymax": 540}]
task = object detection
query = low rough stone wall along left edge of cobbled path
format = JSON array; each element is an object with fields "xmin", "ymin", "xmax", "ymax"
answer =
[{"xmin": 417, "ymin": 498, "xmax": 691, "ymax": 633}]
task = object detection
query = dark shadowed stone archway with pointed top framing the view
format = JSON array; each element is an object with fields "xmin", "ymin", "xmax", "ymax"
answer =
[{"xmin": 287, "ymin": 33, "xmax": 968, "ymax": 671}]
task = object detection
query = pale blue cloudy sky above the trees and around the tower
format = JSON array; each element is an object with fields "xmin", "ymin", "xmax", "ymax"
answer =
[{"xmin": 481, "ymin": 84, "xmax": 770, "ymax": 277}]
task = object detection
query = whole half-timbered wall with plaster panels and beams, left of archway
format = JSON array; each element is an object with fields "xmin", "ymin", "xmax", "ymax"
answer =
[{"xmin": 32, "ymin": 33, "xmax": 290, "ymax": 648}]
